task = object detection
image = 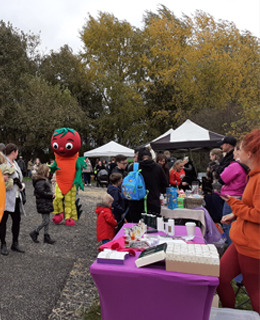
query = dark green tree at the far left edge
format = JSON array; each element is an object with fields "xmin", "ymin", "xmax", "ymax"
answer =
[{"xmin": 0, "ymin": 21, "xmax": 39, "ymax": 141}]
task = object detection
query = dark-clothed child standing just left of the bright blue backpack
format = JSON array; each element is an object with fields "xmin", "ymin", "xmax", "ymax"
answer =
[{"xmin": 107, "ymin": 173, "xmax": 125, "ymax": 222}]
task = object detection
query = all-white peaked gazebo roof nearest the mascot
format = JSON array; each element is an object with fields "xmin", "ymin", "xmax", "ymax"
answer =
[{"xmin": 84, "ymin": 141, "xmax": 135, "ymax": 158}]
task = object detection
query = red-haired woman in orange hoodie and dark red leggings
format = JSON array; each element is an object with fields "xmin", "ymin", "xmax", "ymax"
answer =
[{"xmin": 218, "ymin": 129, "xmax": 260, "ymax": 314}]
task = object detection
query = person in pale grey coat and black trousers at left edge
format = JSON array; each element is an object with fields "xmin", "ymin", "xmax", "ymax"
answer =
[{"xmin": 0, "ymin": 143, "xmax": 25, "ymax": 255}]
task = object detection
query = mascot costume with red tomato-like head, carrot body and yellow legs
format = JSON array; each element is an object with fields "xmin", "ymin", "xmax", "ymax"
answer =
[{"xmin": 50, "ymin": 128, "xmax": 86, "ymax": 226}]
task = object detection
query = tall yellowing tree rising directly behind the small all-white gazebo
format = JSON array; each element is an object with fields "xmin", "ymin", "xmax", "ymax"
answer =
[{"xmin": 81, "ymin": 12, "xmax": 145, "ymax": 146}]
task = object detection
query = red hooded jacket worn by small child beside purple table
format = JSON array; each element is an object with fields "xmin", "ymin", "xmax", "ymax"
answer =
[{"xmin": 95, "ymin": 204, "xmax": 117, "ymax": 241}]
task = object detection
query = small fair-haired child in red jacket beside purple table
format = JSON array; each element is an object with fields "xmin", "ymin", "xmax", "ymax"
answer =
[{"xmin": 95, "ymin": 193, "xmax": 117, "ymax": 244}]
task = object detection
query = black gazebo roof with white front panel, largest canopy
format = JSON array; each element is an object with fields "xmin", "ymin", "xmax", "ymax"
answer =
[{"xmin": 151, "ymin": 119, "xmax": 223, "ymax": 150}]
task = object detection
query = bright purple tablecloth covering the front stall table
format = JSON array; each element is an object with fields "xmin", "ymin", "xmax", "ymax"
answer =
[{"xmin": 89, "ymin": 224, "xmax": 218, "ymax": 320}]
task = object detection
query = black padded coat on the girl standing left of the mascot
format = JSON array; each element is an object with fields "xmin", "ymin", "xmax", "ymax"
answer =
[{"xmin": 33, "ymin": 178, "xmax": 54, "ymax": 213}]
